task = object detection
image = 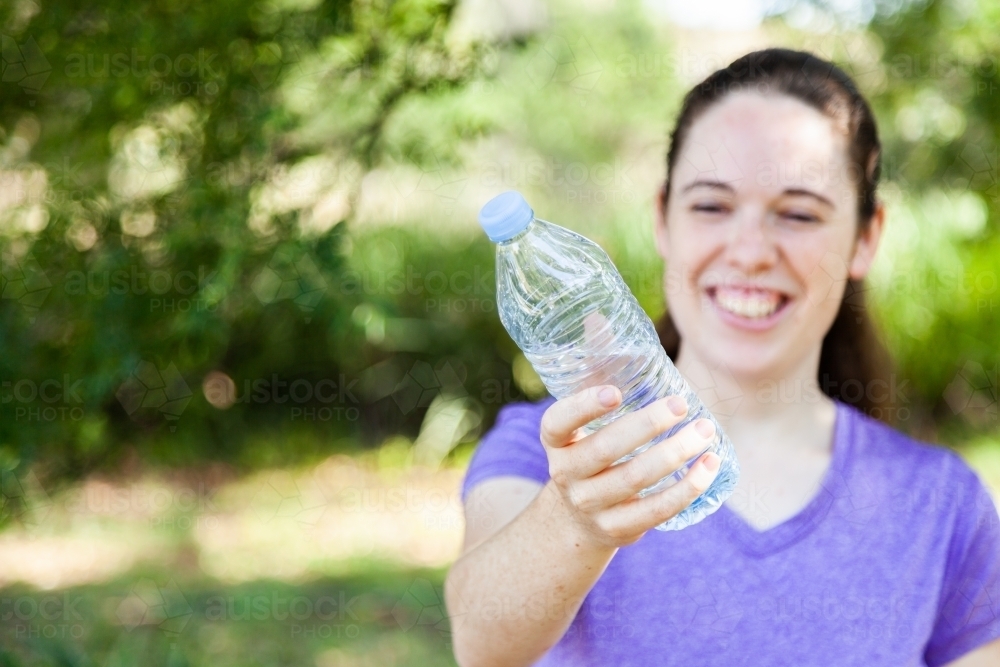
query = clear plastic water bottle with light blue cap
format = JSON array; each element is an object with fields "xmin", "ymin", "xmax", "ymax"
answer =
[{"xmin": 479, "ymin": 192, "xmax": 739, "ymax": 530}]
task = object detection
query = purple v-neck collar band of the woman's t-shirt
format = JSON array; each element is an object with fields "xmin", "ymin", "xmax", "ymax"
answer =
[{"xmin": 715, "ymin": 401, "xmax": 854, "ymax": 557}]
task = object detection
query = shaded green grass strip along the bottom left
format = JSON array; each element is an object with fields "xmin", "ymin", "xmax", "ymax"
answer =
[{"xmin": 0, "ymin": 564, "xmax": 455, "ymax": 667}]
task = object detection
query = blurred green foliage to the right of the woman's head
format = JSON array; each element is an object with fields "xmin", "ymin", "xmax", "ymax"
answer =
[{"xmin": 859, "ymin": 1, "xmax": 1000, "ymax": 432}]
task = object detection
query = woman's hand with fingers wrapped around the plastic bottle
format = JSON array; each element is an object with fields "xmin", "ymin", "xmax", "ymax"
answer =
[{"xmin": 541, "ymin": 385, "xmax": 720, "ymax": 547}]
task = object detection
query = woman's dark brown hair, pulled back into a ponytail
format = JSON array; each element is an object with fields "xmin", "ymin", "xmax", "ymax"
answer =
[{"xmin": 656, "ymin": 49, "xmax": 895, "ymax": 423}]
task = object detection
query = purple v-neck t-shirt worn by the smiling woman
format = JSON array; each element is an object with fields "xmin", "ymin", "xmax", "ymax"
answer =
[{"xmin": 462, "ymin": 398, "xmax": 1000, "ymax": 667}]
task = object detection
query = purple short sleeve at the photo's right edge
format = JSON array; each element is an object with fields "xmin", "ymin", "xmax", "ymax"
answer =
[{"xmin": 924, "ymin": 457, "xmax": 1000, "ymax": 667}]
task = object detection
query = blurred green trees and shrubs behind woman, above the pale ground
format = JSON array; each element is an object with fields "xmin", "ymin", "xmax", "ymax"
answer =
[{"xmin": 0, "ymin": 0, "xmax": 1000, "ymax": 488}]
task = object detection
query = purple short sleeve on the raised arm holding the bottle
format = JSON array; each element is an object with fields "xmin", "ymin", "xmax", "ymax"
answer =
[{"xmin": 462, "ymin": 397, "xmax": 555, "ymax": 503}]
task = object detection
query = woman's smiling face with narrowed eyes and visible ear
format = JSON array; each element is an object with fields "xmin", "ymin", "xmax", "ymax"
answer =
[{"xmin": 656, "ymin": 93, "xmax": 883, "ymax": 381}]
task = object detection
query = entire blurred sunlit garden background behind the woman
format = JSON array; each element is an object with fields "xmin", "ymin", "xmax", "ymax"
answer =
[{"xmin": 0, "ymin": 0, "xmax": 1000, "ymax": 667}]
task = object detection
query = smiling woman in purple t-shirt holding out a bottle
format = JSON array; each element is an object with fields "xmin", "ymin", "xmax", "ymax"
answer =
[{"xmin": 445, "ymin": 49, "xmax": 1000, "ymax": 667}]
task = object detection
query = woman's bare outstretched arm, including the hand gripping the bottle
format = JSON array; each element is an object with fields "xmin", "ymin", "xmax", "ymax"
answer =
[{"xmin": 445, "ymin": 387, "xmax": 719, "ymax": 667}]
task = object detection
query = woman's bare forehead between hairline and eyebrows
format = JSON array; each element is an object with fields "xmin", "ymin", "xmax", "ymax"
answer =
[{"xmin": 671, "ymin": 92, "xmax": 850, "ymax": 196}]
